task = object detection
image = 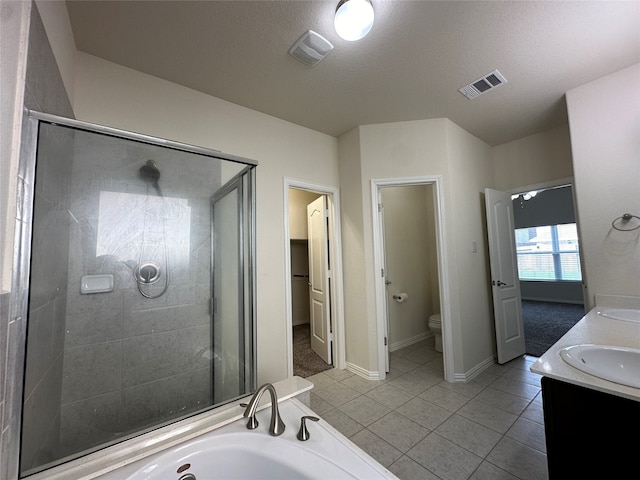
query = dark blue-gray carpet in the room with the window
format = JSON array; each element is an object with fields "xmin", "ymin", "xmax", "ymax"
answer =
[{"xmin": 522, "ymin": 300, "xmax": 584, "ymax": 357}]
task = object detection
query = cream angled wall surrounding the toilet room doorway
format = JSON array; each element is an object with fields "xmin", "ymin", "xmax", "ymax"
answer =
[{"xmin": 340, "ymin": 119, "xmax": 493, "ymax": 376}]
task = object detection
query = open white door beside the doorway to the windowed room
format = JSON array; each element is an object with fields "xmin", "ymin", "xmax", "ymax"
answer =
[{"xmin": 484, "ymin": 188, "xmax": 525, "ymax": 364}]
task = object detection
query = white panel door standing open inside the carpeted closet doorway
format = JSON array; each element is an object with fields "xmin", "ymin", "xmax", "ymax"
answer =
[{"xmin": 307, "ymin": 195, "xmax": 333, "ymax": 365}]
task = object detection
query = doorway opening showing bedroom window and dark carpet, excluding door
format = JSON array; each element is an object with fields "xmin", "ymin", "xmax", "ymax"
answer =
[{"xmin": 511, "ymin": 182, "xmax": 585, "ymax": 357}]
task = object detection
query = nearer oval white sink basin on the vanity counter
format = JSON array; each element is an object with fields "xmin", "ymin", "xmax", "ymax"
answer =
[{"xmin": 560, "ymin": 345, "xmax": 640, "ymax": 388}]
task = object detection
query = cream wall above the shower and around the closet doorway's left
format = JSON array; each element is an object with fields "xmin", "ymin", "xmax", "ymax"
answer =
[{"xmin": 74, "ymin": 53, "xmax": 338, "ymax": 383}]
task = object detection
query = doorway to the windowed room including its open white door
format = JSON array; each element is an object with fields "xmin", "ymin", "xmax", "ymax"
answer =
[{"xmin": 485, "ymin": 180, "xmax": 584, "ymax": 364}]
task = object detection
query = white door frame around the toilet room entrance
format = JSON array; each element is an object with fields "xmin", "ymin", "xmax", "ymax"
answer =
[{"xmin": 371, "ymin": 175, "xmax": 455, "ymax": 382}]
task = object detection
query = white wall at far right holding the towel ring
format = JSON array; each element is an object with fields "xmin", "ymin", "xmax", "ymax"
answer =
[{"xmin": 567, "ymin": 64, "xmax": 640, "ymax": 308}]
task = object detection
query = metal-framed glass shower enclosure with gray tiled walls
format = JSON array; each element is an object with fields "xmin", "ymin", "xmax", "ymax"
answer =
[{"xmin": 20, "ymin": 112, "xmax": 256, "ymax": 476}]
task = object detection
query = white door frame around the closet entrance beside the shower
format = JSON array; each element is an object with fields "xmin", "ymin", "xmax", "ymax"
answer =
[{"xmin": 283, "ymin": 177, "xmax": 346, "ymax": 378}]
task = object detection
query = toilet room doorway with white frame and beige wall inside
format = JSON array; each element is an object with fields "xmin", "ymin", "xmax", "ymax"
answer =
[{"xmin": 371, "ymin": 176, "xmax": 453, "ymax": 381}]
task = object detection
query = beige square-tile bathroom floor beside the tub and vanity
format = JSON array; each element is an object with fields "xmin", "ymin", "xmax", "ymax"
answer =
[{"xmin": 307, "ymin": 339, "xmax": 548, "ymax": 480}]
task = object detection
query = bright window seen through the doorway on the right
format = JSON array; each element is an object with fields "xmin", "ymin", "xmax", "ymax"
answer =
[{"xmin": 515, "ymin": 223, "xmax": 582, "ymax": 281}]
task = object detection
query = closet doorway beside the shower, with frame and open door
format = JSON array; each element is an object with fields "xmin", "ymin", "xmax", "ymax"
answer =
[{"xmin": 284, "ymin": 179, "xmax": 345, "ymax": 377}]
